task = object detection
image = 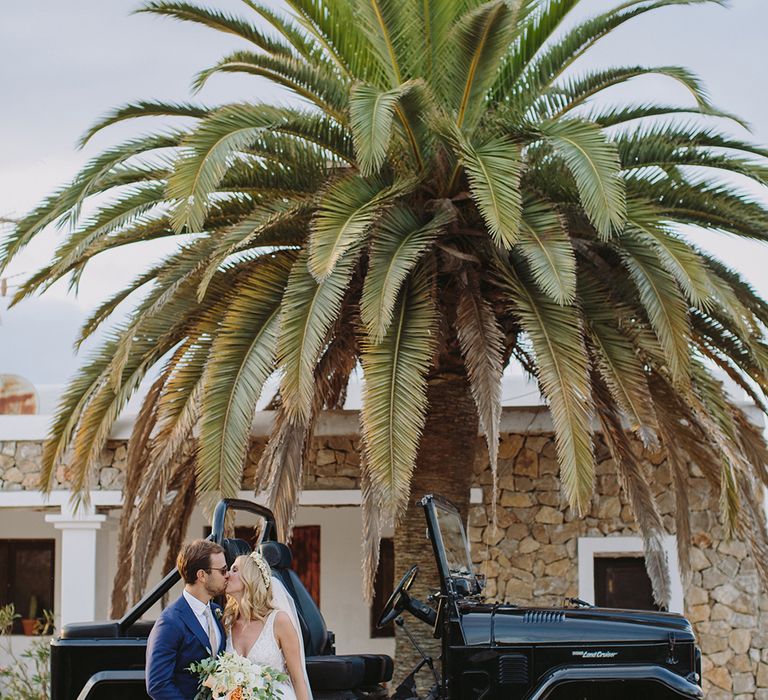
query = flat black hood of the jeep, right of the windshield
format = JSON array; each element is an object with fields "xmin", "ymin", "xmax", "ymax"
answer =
[{"xmin": 459, "ymin": 604, "xmax": 694, "ymax": 646}]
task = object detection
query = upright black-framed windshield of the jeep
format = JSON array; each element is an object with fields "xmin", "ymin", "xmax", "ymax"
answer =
[{"xmin": 422, "ymin": 496, "xmax": 479, "ymax": 593}]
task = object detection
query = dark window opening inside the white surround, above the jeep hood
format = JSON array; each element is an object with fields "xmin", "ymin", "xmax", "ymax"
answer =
[{"xmin": 595, "ymin": 557, "xmax": 659, "ymax": 610}]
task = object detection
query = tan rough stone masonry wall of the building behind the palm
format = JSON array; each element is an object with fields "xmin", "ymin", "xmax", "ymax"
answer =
[{"xmin": 0, "ymin": 434, "xmax": 768, "ymax": 700}]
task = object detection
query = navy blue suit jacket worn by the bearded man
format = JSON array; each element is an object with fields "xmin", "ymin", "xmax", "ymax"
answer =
[{"xmin": 146, "ymin": 595, "xmax": 226, "ymax": 700}]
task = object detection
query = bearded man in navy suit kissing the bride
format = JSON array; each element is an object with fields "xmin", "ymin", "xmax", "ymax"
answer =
[{"xmin": 146, "ymin": 540, "xmax": 229, "ymax": 700}]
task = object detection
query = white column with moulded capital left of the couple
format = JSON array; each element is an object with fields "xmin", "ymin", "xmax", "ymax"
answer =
[{"xmin": 45, "ymin": 503, "xmax": 107, "ymax": 625}]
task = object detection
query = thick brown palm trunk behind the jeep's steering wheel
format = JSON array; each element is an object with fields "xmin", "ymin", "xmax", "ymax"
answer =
[{"xmin": 395, "ymin": 374, "xmax": 478, "ymax": 688}]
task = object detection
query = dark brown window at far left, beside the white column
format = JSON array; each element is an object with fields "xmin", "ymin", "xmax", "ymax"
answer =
[{"xmin": 0, "ymin": 540, "xmax": 55, "ymax": 634}]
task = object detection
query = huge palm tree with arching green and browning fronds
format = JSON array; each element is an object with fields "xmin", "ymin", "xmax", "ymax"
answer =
[{"xmin": 0, "ymin": 0, "xmax": 768, "ymax": 668}]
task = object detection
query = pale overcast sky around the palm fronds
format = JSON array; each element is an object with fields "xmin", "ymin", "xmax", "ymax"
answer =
[{"xmin": 0, "ymin": 0, "xmax": 768, "ymax": 384}]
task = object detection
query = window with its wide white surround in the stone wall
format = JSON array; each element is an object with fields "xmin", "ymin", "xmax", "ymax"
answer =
[{"xmin": 578, "ymin": 535, "xmax": 684, "ymax": 614}]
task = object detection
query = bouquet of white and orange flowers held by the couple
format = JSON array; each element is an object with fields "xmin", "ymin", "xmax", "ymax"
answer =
[{"xmin": 189, "ymin": 651, "xmax": 288, "ymax": 700}]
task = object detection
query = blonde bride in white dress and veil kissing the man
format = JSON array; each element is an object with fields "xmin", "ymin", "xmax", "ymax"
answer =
[{"xmin": 223, "ymin": 552, "xmax": 311, "ymax": 700}]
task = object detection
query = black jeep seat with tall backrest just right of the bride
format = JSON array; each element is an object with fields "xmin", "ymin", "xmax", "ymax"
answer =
[{"xmin": 261, "ymin": 542, "xmax": 394, "ymax": 691}]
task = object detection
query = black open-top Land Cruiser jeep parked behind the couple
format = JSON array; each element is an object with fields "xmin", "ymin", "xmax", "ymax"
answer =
[{"xmin": 51, "ymin": 496, "xmax": 703, "ymax": 700}]
